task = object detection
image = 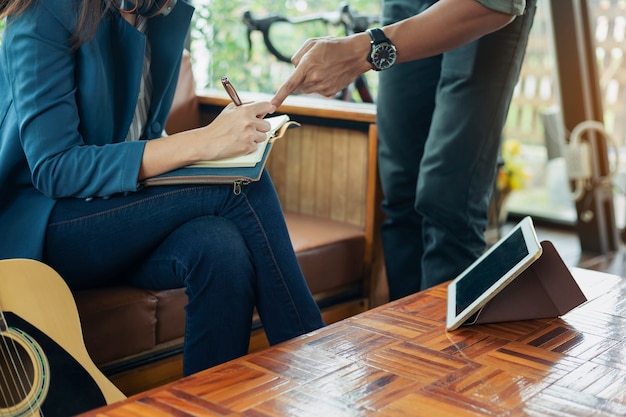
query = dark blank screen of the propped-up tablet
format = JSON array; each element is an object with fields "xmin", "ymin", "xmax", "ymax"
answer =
[{"xmin": 456, "ymin": 229, "xmax": 528, "ymax": 315}]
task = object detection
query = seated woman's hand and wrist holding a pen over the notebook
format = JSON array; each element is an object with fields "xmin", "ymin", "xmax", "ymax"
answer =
[{"xmin": 138, "ymin": 102, "xmax": 276, "ymax": 180}]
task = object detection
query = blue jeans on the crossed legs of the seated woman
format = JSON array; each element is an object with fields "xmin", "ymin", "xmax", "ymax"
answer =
[{"xmin": 44, "ymin": 172, "xmax": 324, "ymax": 375}]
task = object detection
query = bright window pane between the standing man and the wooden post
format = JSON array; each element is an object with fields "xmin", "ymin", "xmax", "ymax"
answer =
[{"xmin": 503, "ymin": 0, "xmax": 576, "ymax": 224}]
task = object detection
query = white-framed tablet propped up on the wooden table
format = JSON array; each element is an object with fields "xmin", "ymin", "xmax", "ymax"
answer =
[{"xmin": 446, "ymin": 217, "xmax": 542, "ymax": 330}]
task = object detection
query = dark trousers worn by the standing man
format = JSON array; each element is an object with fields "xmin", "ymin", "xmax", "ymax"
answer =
[{"xmin": 377, "ymin": 0, "xmax": 536, "ymax": 300}]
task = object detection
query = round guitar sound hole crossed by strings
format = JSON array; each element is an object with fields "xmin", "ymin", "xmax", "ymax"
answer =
[{"xmin": 0, "ymin": 335, "xmax": 39, "ymax": 409}]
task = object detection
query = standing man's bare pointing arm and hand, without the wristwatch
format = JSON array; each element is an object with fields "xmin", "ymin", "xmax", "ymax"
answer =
[{"xmin": 271, "ymin": 0, "xmax": 519, "ymax": 107}]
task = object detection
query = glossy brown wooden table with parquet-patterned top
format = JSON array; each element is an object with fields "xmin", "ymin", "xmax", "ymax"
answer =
[{"xmin": 83, "ymin": 269, "xmax": 626, "ymax": 417}]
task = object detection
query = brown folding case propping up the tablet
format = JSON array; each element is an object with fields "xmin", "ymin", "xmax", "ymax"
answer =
[{"xmin": 468, "ymin": 241, "xmax": 587, "ymax": 324}]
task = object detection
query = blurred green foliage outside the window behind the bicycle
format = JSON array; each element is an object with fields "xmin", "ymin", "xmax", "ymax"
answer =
[{"xmin": 0, "ymin": 0, "xmax": 380, "ymax": 97}]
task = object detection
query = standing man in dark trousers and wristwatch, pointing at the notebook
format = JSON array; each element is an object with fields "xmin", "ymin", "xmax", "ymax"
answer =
[{"xmin": 272, "ymin": 0, "xmax": 536, "ymax": 300}]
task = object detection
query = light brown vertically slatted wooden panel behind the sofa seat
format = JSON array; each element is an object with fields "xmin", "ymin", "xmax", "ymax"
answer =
[{"xmin": 267, "ymin": 124, "xmax": 369, "ymax": 227}]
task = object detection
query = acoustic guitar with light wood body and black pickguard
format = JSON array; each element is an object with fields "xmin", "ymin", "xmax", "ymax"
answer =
[{"xmin": 0, "ymin": 259, "xmax": 125, "ymax": 417}]
